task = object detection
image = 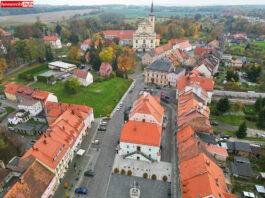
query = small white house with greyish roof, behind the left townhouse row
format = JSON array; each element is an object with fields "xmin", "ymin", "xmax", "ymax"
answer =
[{"xmin": 18, "ymin": 100, "xmax": 42, "ymax": 116}]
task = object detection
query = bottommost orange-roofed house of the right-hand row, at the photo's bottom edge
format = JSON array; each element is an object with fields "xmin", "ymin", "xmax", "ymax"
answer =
[{"xmin": 179, "ymin": 153, "xmax": 235, "ymax": 198}]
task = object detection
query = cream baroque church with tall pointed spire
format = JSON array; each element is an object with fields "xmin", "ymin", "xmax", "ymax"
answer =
[{"xmin": 133, "ymin": 2, "xmax": 159, "ymax": 52}]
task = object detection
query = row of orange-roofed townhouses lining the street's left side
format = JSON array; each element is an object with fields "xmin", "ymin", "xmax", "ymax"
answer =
[{"xmin": 4, "ymin": 85, "xmax": 94, "ymax": 198}]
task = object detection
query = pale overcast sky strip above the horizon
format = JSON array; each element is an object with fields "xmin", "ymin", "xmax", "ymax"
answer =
[{"xmin": 36, "ymin": 0, "xmax": 265, "ymax": 6}]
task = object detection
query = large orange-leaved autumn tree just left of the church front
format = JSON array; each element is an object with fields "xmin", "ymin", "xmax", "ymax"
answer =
[{"xmin": 118, "ymin": 46, "xmax": 136, "ymax": 71}]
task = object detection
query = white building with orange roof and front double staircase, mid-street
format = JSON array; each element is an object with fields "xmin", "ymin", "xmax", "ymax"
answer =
[{"xmin": 118, "ymin": 120, "xmax": 162, "ymax": 162}]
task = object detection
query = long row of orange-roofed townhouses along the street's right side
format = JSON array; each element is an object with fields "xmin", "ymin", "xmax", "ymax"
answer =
[{"xmin": 177, "ymin": 71, "xmax": 235, "ymax": 198}]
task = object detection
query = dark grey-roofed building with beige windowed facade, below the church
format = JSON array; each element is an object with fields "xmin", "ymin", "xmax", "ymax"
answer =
[{"xmin": 144, "ymin": 57, "xmax": 174, "ymax": 86}]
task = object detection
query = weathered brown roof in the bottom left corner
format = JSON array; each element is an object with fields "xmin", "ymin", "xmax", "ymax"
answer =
[{"xmin": 4, "ymin": 161, "xmax": 54, "ymax": 198}]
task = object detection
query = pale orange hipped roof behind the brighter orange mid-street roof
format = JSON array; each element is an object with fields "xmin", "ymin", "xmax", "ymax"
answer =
[{"xmin": 130, "ymin": 93, "xmax": 165, "ymax": 123}]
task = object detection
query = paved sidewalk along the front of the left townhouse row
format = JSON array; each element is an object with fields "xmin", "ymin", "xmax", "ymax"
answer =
[{"xmin": 53, "ymin": 119, "xmax": 100, "ymax": 198}]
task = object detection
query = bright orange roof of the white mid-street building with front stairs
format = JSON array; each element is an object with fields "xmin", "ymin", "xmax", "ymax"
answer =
[{"xmin": 120, "ymin": 120, "xmax": 162, "ymax": 147}]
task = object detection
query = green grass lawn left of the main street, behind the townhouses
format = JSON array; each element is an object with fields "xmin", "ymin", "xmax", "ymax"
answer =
[{"xmin": 32, "ymin": 78, "xmax": 132, "ymax": 117}]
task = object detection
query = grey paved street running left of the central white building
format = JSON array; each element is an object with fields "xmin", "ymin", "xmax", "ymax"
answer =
[{"xmin": 74, "ymin": 77, "xmax": 143, "ymax": 198}]
